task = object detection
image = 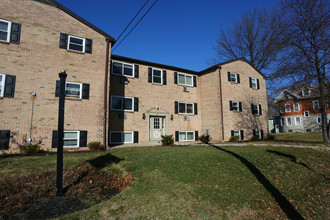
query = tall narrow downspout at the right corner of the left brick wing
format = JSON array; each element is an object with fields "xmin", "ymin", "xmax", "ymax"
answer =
[{"xmin": 103, "ymin": 39, "xmax": 110, "ymax": 150}]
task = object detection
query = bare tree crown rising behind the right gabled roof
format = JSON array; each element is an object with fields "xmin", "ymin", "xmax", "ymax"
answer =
[{"xmin": 215, "ymin": 9, "xmax": 279, "ymax": 70}]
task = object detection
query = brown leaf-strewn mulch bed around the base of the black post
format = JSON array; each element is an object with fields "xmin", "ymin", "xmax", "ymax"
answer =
[{"xmin": 0, "ymin": 162, "xmax": 134, "ymax": 219}]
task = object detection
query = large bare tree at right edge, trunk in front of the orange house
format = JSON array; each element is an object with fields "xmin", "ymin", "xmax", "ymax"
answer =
[{"xmin": 272, "ymin": 0, "xmax": 330, "ymax": 143}]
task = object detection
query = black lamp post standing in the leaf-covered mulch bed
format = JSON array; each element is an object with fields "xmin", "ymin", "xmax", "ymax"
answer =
[{"xmin": 56, "ymin": 70, "xmax": 67, "ymax": 197}]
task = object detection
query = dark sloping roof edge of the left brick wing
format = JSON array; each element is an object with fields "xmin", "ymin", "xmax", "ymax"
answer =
[{"xmin": 34, "ymin": 0, "xmax": 116, "ymax": 44}]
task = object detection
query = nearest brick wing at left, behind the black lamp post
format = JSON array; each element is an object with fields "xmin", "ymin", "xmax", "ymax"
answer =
[{"xmin": 0, "ymin": 0, "xmax": 115, "ymax": 151}]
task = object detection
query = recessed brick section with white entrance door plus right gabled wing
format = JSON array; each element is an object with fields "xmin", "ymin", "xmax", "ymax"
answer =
[{"xmin": 109, "ymin": 55, "xmax": 268, "ymax": 144}]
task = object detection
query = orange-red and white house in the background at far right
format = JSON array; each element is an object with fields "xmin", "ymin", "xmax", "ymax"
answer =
[{"xmin": 275, "ymin": 85, "xmax": 330, "ymax": 132}]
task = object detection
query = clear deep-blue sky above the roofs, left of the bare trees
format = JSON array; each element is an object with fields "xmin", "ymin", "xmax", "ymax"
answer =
[{"xmin": 58, "ymin": 0, "xmax": 277, "ymax": 71}]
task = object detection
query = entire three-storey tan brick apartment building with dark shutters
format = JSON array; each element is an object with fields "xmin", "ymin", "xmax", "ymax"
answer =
[{"xmin": 0, "ymin": 0, "xmax": 268, "ymax": 152}]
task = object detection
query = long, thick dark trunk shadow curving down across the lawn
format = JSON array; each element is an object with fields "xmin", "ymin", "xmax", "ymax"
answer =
[{"xmin": 211, "ymin": 145, "xmax": 304, "ymax": 219}]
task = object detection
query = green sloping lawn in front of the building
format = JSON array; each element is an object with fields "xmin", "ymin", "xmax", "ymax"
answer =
[{"xmin": 0, "ymin": 146, "xmax": 330, "ymax": 219}]
